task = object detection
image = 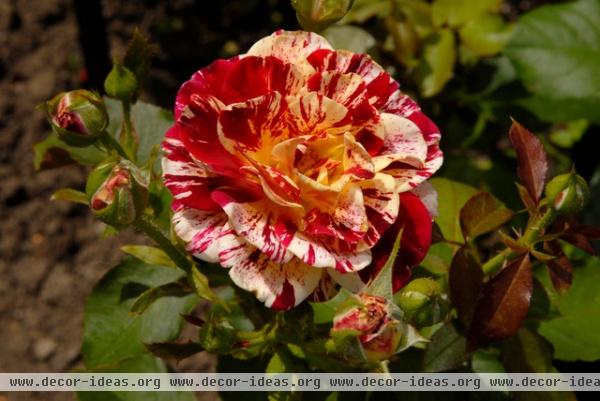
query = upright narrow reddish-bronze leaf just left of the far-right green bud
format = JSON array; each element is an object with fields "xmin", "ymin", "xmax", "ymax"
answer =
[{"xmin": 508, "ymin": 120, "xmax": 548, "ymax": 204}]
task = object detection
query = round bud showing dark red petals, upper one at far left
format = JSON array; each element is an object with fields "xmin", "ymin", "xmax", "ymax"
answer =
[{"xmin": 46, "ymin": 89, "xmax": 108, "ymax": 147}]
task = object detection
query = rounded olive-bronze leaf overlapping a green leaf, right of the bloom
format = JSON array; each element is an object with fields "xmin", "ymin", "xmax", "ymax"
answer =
[{"xmin": 460, "ymin": 192, "xmax": 513, "ymax": 238}]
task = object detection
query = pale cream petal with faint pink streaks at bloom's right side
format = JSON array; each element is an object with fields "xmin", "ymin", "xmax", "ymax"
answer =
[{"xmin": 373, "ymin": 113, "xmax": 427, "ymax": 171}]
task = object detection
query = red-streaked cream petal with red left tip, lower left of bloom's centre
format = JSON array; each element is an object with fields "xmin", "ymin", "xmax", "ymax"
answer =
[{"xmin": 212, "ymin": 191, "xmax": 293, "ymax": 263}]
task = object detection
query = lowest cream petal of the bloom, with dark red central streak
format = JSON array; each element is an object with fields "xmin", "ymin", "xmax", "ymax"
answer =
[{"xmin": 229, "ymin": 248, "xmax": 322, "ymax": 310}]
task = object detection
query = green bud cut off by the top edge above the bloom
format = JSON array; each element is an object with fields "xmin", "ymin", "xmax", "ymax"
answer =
[{"xmin": 292, "ymin": 0, "xmax": 354, "ymax": 31}]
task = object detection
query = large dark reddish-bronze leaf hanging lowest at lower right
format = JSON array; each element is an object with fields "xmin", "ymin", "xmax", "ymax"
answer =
[{"xmin": 468, "ymin": 254, "xmax": 533, "ymax": 350}]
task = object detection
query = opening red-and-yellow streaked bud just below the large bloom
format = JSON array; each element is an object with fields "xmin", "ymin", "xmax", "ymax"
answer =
[{"xmin": 331, "ymin": 294, "xmax": 402, "ymax": 362}]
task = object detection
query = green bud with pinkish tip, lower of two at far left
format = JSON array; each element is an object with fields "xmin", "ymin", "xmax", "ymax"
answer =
[{"xmin": 86, "ymin": 161, "xmax": 148, "ymax": 228}]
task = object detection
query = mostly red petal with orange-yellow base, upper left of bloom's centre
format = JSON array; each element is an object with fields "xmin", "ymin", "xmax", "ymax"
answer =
[{"xmin": 218, "ymin": 92, "xmax": 288, "ymax": 159}]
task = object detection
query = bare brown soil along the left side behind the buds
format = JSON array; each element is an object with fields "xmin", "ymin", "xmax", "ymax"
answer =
[{"xmin": 0, "ymin": 0, "xmax": 221, "ymax": 401}]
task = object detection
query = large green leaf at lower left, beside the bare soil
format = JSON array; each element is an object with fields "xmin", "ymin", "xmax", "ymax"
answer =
[{"xmin": 82, "ymin": 259, "xmax": 198, "ymax": 368}]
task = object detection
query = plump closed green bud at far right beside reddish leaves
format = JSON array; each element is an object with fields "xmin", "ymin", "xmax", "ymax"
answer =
[{"xmin": 546, "ymin": 171, "xmax": 590, "ymax": 215}]
